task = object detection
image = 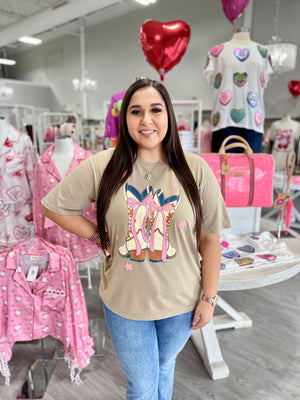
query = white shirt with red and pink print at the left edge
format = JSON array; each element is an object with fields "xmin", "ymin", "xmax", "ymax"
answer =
[{"xmin": 0, "ymin": 123, "xmax": 36, "ymax": 248}]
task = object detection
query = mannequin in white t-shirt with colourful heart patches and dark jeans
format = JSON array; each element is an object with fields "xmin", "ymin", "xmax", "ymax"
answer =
[{"xmin": 204, "ymin": 28, "xmax": 272, "ymax": 153}]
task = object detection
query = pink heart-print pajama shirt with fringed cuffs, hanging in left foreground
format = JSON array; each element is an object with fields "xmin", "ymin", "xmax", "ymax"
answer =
[{"xmin": 0, "ymin": 238, "xmax": 94, "ymax": 385}]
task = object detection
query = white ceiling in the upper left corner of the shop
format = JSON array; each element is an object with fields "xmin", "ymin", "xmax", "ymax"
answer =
[{"xmin": 0, "ymin": 0, "xmax": 143, "ymax": 56}]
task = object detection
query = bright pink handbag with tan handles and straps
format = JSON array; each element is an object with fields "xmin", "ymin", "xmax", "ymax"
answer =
[{"xmin": 200, "ymin": 135, "xmax": 274, "ymax": 207}]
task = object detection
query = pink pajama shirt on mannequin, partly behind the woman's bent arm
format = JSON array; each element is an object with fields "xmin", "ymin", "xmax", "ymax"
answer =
[{"xmin": 33, "ymin": 142, "xmax": 100, "ymax": 263}]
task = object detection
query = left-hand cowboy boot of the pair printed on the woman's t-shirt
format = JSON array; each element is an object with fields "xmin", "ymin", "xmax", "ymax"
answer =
[{"xmin": 119, "ymin": 184, "xmax": 153, "ymax": 262}]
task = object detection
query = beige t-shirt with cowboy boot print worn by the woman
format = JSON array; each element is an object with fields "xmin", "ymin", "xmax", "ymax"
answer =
[{"xmin": 42, "ymin": 149, "xmax": 230, "ymax": 320}]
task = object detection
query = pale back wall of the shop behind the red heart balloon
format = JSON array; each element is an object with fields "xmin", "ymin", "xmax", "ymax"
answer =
[{"xmin": 9, "ymin": 0, "xmax": 300, "ymax": 118}]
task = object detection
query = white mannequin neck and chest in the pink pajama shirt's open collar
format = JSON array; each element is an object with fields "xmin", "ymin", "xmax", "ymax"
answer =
[{"xmin": 52, "ymin": 136, "xmax": 74, "ymax": 178}]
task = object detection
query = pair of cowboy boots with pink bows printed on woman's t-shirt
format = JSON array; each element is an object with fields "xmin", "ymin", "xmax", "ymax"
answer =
[{"xmin": 119, "ymin": 184, "xmax": 179, "ymax": 262}]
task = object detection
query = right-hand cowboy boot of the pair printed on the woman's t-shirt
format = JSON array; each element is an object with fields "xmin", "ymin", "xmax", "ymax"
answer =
[{"xmin": 149, "ymin": 190, "xmax": 179, "ymax": 262}]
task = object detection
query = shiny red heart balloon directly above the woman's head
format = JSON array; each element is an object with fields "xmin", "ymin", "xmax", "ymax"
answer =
[{"xmin": 140, "ymin": 20, "xmax": 191, "ymax": 81}]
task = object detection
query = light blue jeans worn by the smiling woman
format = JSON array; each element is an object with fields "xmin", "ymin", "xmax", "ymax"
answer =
[{"xmin": 104, "ymin": 305, "xmax": 194, "ymax": 400}]
